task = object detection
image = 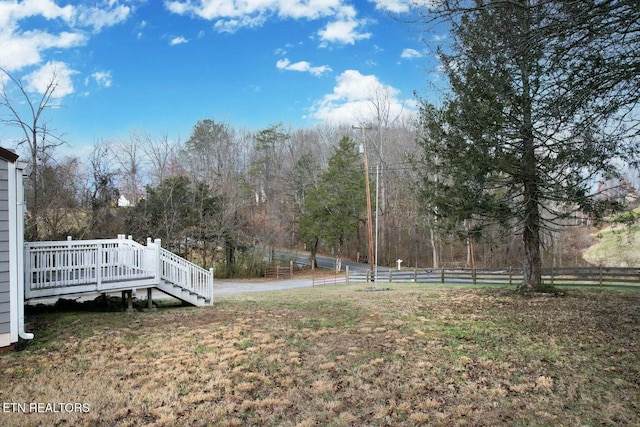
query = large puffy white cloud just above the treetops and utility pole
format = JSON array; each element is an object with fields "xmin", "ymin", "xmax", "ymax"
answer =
[{"xmin": 310, "ymin": 70, "xmax": 413, "ymax": 124}]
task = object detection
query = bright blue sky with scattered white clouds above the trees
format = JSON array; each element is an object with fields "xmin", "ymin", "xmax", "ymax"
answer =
[{"xmin": 0, "ymin": 0, "xmax": 444, "ymax": 151}]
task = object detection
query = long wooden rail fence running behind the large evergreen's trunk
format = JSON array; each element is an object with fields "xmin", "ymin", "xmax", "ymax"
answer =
[{"xmin": 348, "ymin": 267, "xmax": 640, "ymax": 287}]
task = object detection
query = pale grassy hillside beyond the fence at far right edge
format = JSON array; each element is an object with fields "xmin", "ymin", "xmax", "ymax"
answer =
[{"xmin": 583, "ymin": 208, "xmax": 640, "ymax": 267}]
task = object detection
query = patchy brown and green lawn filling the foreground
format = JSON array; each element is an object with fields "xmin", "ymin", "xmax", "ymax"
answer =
[{"xmin": 0, "ymin": 284, "xmax": 640, "ymax": 426}]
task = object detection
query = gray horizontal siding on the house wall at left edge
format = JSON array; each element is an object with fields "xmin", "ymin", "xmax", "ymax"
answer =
[{"xmin": 0, "ymin": 158, "xmax": 11, "ymax": 334}]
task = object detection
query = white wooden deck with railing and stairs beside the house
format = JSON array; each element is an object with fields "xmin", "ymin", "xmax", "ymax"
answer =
[{"xmin": 24, "ymin": 235, "xmax": 213, "ymax": 306}]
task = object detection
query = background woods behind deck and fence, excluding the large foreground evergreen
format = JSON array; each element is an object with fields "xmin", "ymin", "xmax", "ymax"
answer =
[{"xmin": 11, "ymin": 119, "xmax": 636, "ymax": 277}]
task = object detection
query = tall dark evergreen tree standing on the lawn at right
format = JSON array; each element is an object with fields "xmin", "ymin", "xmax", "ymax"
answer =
[{"xmin": 412, "ymin": 0, "xmax": 633, "ymax": 290}]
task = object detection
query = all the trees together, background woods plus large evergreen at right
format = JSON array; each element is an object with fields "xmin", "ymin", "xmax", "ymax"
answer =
[{"xmin": 5, "ymin": 0, "xmax": 640, "ymax": 290}]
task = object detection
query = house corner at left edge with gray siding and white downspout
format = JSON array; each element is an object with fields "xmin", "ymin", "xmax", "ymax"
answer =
[{"xmin": 0, "ymin": 147, "xmax": 33, "ymax": 348}]
